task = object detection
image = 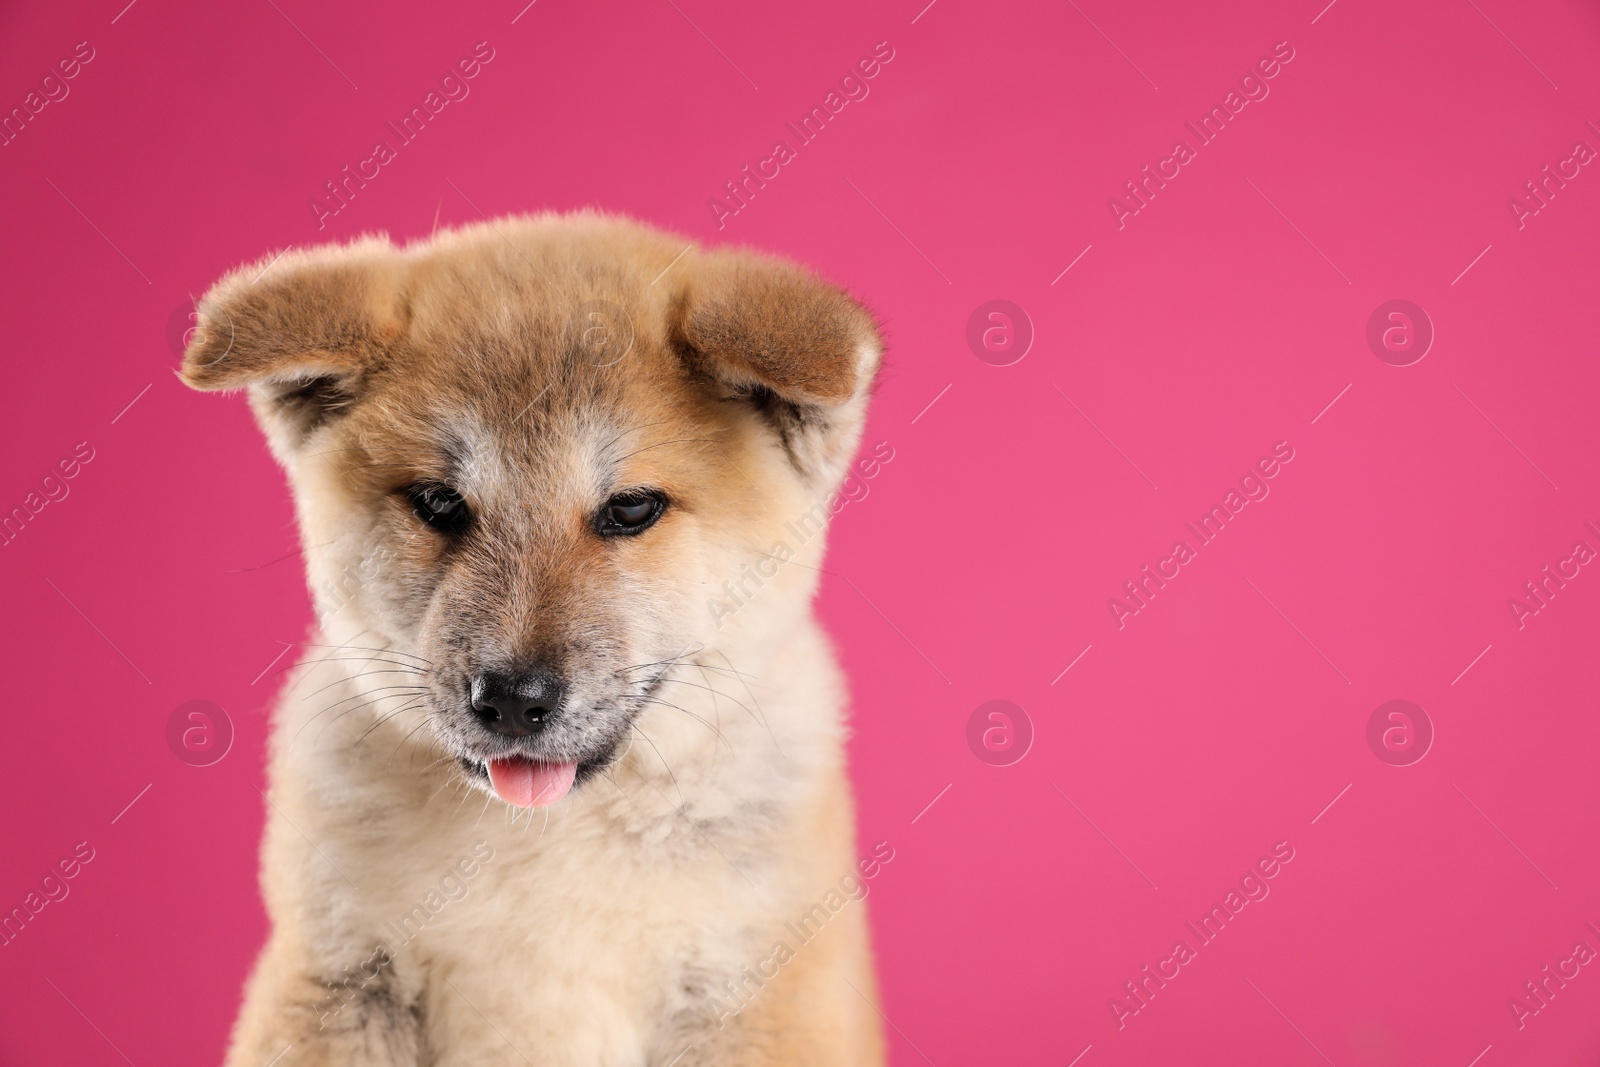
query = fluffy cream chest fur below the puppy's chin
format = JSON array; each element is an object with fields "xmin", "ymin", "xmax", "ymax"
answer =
[{"xmin": 264, "ymin": 604, "xmax": 870, "ymax": 1067}]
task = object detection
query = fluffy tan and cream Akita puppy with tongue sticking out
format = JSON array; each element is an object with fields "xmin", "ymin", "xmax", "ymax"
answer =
[{"xmin": 182, "ymin": 214, "xmax": 893, "ymax": 1067}]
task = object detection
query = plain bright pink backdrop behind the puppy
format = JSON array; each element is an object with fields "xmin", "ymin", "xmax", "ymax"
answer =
[{"xmin": 0, "ymin": 0, "xmax": 1600, "ymax": 1067}]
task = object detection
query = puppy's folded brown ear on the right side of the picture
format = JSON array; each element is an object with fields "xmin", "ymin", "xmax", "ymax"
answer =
[{"xmin": 675, "ymin": 251, "xmax": 883, "ymax": 483}]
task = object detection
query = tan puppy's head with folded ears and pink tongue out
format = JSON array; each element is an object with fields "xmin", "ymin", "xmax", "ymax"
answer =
[{"xmin": 182, "ymin": 216, "xmax": 878, "ymax": 805}]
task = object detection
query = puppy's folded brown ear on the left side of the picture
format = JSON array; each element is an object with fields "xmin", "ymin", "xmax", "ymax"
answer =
[{"xmin": 179, "ymin": 238, "xmax": 410, "ymax": 456}]
